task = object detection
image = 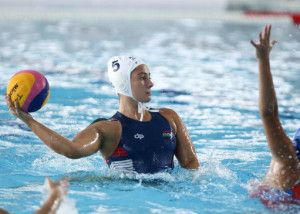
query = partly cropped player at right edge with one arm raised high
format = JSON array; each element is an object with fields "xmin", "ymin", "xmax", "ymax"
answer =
[{"xmin": 251, "ymin": 25, "xmax": 300, "ymax": 199}]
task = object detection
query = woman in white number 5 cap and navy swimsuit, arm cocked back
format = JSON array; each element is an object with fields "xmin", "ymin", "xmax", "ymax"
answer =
[{"xmin": 6, "ymin": 56, "xmax": 199, "ymax": 173}]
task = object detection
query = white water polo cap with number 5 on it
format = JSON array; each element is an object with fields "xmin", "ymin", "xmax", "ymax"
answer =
[{"xmin": 107, "ymin": 56, "xmax": 145, "ymax": 99}]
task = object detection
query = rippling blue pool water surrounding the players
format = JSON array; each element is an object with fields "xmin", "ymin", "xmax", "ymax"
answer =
[{"xmin": 0, "ymin": 20, "xmax": 300, "ymax": 213}]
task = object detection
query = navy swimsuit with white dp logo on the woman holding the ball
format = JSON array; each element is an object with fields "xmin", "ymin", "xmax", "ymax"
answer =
[{"xmin": 106, "ymin": 112, "xmax": 176, "ymax": 173}]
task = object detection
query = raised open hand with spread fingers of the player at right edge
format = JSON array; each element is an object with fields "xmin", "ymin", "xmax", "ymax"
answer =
[{"xmin": 250, "ymin": 25, "xmax": 277, "ymax": 59}]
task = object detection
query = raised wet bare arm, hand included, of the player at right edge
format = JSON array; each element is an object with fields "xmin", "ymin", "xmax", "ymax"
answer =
[{"xmin": 251, "ymin": 25, "xmax": 297, "ymax": 166}]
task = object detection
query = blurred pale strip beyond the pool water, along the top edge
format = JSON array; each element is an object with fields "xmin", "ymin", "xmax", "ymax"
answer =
[{"xmin": 0, "ymin": 0, "xmax": 300, "ymax": 23}]
